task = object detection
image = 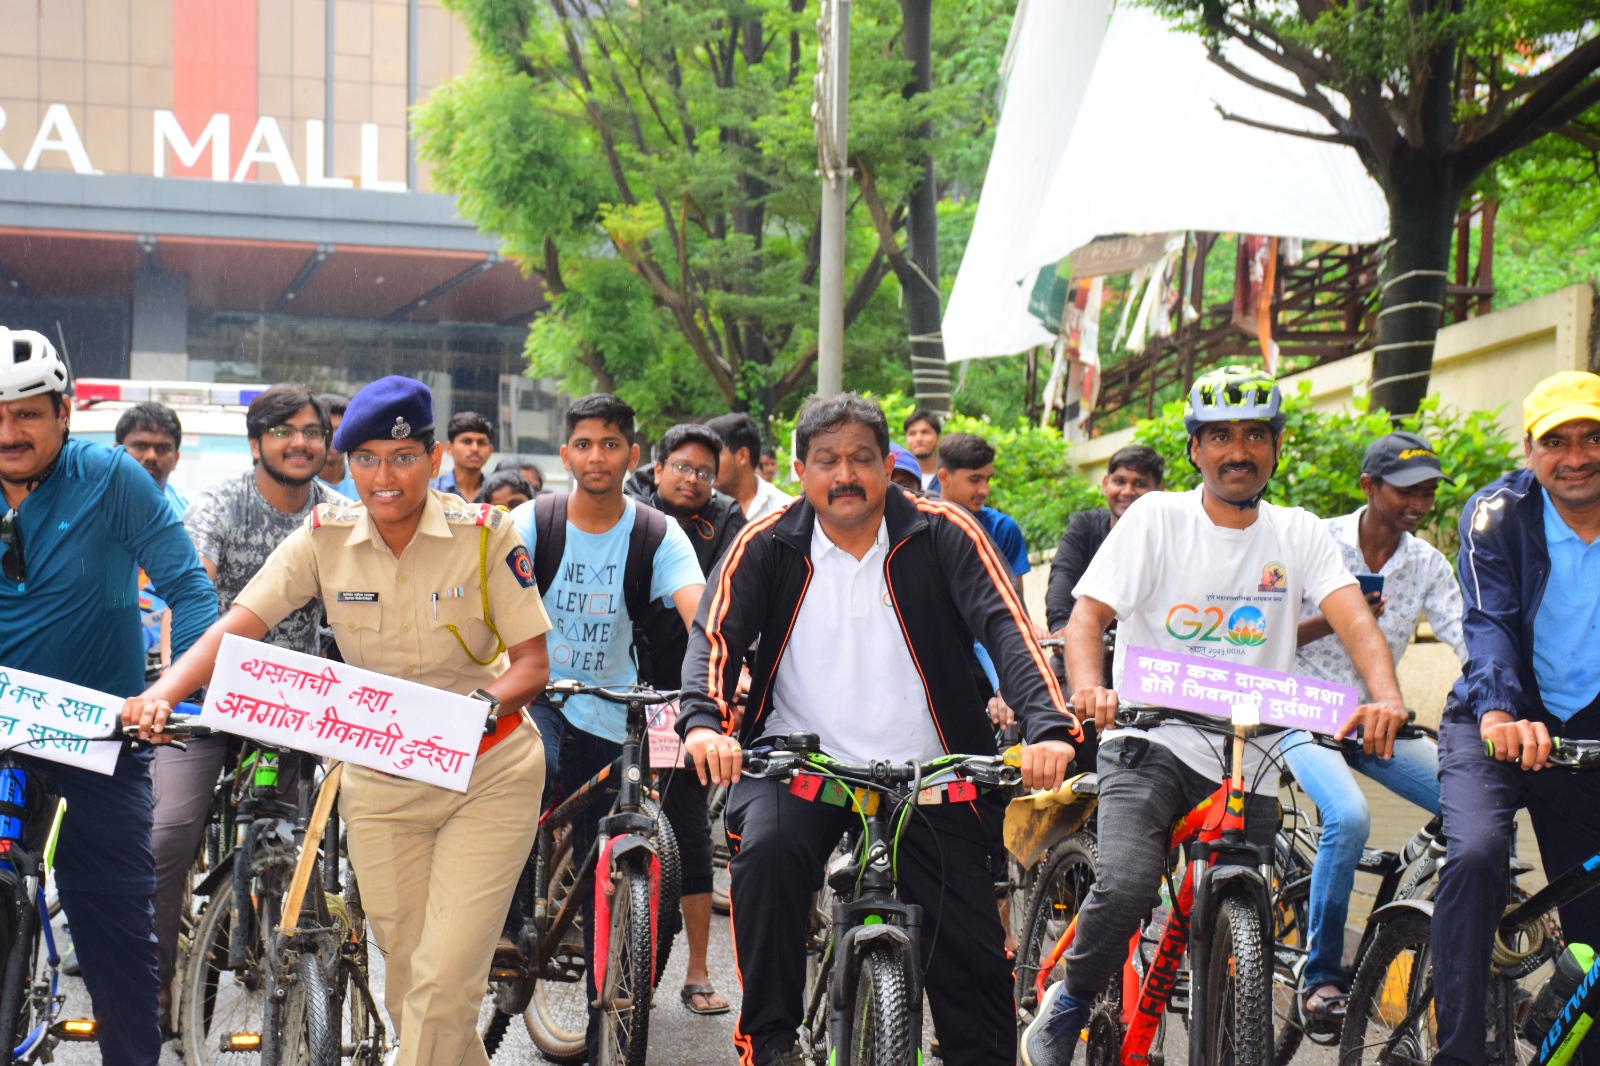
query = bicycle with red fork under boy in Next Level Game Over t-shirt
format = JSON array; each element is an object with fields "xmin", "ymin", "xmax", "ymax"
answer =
[{"xmin": 482, "ymin": 680, "xmax": 682, "ymax": 1066}]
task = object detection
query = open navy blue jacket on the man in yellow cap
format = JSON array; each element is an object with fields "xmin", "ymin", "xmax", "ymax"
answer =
[{"xmin": 1445, "ymin": 471, "xmax": 1574, "ymax": 722}]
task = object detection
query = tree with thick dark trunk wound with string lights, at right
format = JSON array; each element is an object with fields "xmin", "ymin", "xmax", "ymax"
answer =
[{"xmin": 1147, "ymin": 0, "xmax": 1600, "ymax": 415}]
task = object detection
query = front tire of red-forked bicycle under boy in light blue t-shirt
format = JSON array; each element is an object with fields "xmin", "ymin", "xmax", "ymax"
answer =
[{"xmin": 595, "ymin": 858, "xmax": 654, "ymax": 1066}]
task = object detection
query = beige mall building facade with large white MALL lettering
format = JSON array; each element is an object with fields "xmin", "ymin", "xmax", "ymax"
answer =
[{"xmin": 0, "ymin": 0, "xmax": 563, "ymax": 453}]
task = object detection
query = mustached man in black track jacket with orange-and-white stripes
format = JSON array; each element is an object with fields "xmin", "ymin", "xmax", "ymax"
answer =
[{"xmin": 678, "ymin": 394, "xmax": 1080, "ymax": 1066}]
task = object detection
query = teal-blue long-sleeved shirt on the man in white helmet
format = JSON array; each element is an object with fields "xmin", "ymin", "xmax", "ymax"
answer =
[{"xmin": 0, "ymin": 439, "xmax": 216, "ymax": 696}]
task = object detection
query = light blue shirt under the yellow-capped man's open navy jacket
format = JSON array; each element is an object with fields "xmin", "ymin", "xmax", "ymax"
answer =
[{"xmin": 1533, "ymin": 496, "xmax": 1600, "ymax": 722}]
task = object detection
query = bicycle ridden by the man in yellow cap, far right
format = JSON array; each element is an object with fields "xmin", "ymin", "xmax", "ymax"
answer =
[{"xmin": 1339, "ymin": 738, "xmax": 1600, "ymax": 1066}]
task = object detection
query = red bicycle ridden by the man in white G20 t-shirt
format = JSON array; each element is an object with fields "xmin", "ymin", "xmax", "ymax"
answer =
[{"xmin": 1034, "ymin": 711, "xmax": 1272, "ymax": 1066}]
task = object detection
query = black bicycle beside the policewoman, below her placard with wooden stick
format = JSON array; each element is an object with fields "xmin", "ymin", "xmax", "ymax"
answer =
[{"xmin": 182, "ymin": 729, "xmax": 387, "ymax": 1066}]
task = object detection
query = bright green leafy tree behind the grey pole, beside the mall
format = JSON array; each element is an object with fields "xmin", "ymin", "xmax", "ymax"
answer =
[{"xmin": 418, "ymin": 0, "xmax": 1010, "ymax": 427}]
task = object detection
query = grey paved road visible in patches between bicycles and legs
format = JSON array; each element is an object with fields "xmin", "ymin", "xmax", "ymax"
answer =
[{"xmin": 43, "ymin": 778, "xmax": 1542, "ymax": 1066}]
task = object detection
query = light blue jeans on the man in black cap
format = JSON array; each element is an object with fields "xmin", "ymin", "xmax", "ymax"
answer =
[{"xmin": 1280, "ymin": 731, "xmax": 1438, "ymax": 989}]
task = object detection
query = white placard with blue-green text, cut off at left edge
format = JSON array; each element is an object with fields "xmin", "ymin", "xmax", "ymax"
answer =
[{"xmin": 0, "ymin": 666, "xmax": 123, "ymax": 773}]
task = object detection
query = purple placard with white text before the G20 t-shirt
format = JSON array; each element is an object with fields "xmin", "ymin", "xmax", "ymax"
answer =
[{"xmin": 1122, "ymin": 648, "xmax": 1362, "ymax": 735}]
